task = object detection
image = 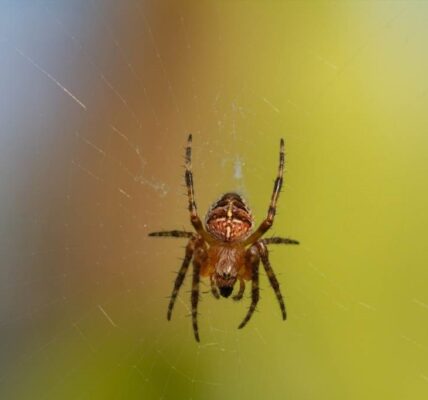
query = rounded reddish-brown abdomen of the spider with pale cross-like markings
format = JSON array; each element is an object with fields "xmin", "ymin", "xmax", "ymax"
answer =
[{"xmin": 205, "ymin": 193, "xmax": 253, "ymax": 242}]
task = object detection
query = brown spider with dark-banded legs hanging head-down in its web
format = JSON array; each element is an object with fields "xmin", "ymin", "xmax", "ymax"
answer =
[{"xmin": 149, "ymin": 135, "xmax": 299, "ymax": 342}]
